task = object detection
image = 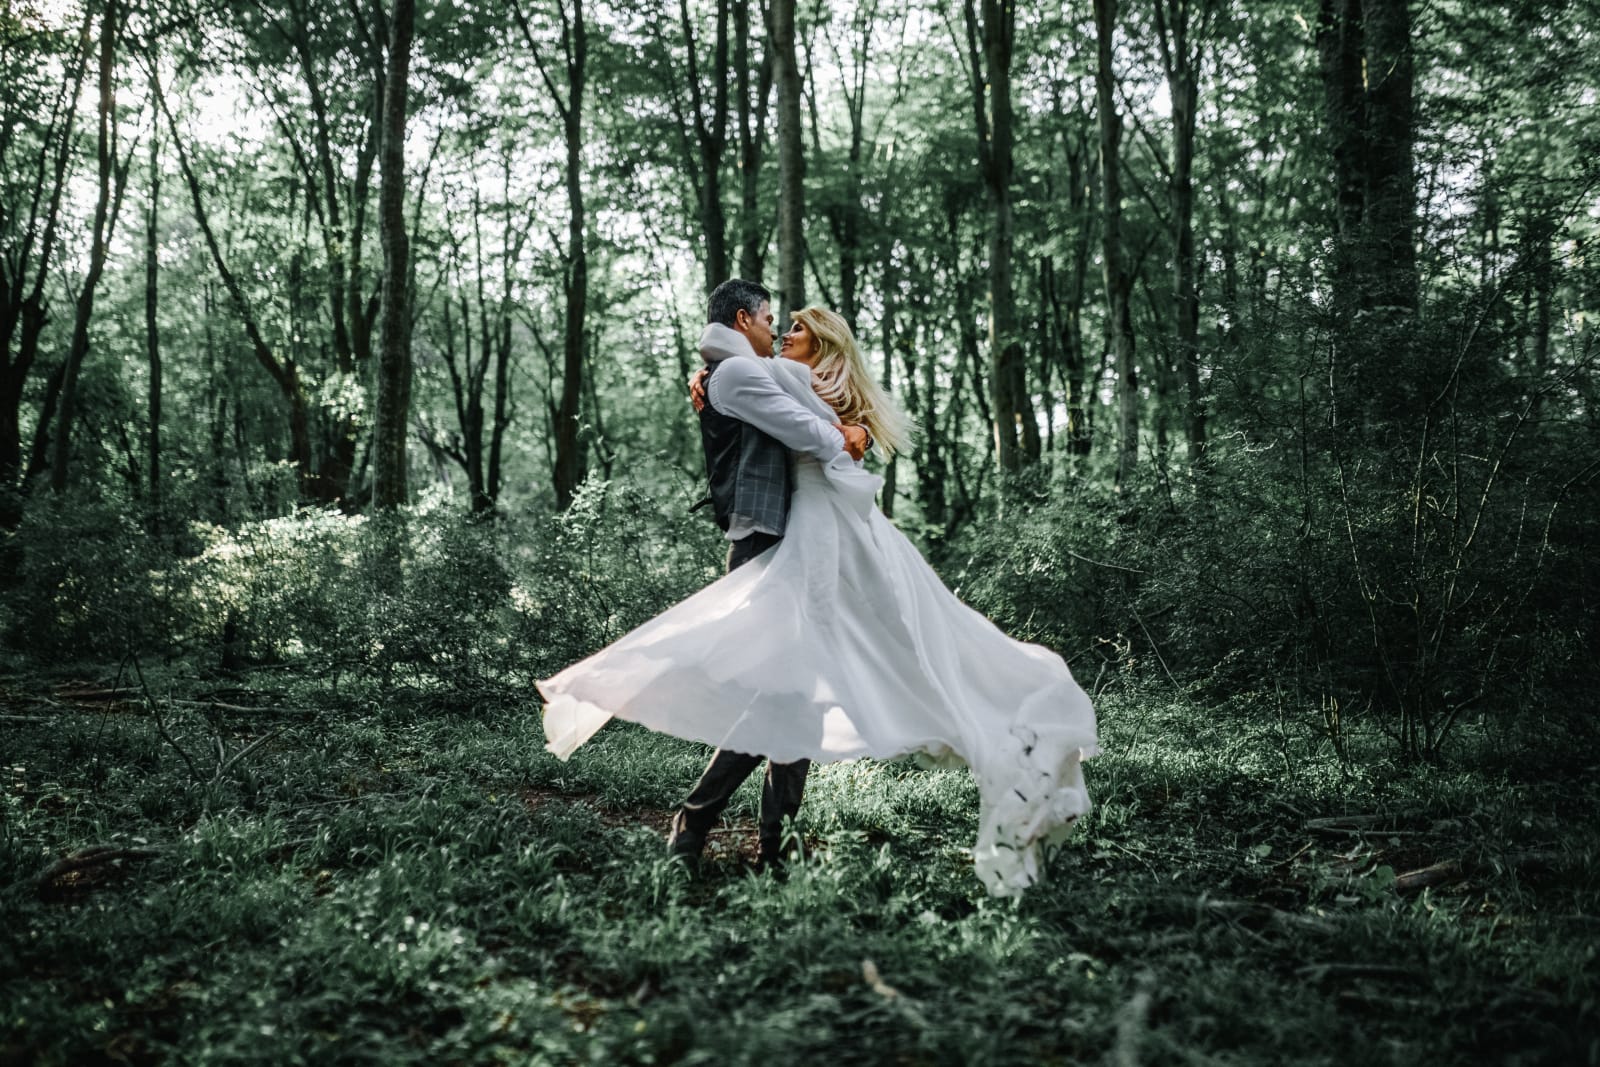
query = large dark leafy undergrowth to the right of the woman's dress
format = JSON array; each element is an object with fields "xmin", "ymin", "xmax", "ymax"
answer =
[{"xmin": 947, "ymin": 296, "xmax": 1600, "ymax": 758}]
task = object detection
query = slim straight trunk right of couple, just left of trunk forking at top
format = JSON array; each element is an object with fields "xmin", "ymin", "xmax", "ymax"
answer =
[{"xmin": 1094, "ymin": 0, "xmax": 1139, "ymax": 486}]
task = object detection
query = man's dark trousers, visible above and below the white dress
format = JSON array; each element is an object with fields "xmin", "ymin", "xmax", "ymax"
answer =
[{"xmin": 667, "ymin": 533, "xmax": 811, "ymax": 859}]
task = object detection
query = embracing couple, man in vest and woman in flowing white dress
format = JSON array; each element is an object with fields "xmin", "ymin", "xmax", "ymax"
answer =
[{"xmin": 539, "ymin": 280, "xmax": 1098, "ymax": 896}]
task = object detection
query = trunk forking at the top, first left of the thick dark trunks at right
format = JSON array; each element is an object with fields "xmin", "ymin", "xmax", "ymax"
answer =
[{"xmin": 1155, "ymin": 0, "xmax": 1211, "ymax": 464}]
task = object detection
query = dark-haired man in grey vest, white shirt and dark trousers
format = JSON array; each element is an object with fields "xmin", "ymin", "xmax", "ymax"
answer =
[{"xmin": 667, "ymin": 278, "xmax": 867, "ymax": 869}]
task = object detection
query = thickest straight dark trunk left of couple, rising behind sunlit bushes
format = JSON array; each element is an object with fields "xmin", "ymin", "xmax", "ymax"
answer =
[{"xmin": 373, "ymin": 0, "xmax": 416, "ymax": 510}]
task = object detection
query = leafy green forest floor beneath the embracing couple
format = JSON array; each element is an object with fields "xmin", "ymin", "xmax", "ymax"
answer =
[{"xmin": 0, "ymin": 669, "xmax": 1600, "ymax": 1067}]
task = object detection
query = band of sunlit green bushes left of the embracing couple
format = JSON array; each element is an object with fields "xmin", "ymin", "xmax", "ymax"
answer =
[{"xmin": 5, "ymin": 478, "xmax": 725, "ymax": 693}]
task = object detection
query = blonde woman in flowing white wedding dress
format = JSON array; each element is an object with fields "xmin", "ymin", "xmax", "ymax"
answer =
[{"xmin": 539, "ymin": 307, "xmax": 1098, "ymax": 896}]
